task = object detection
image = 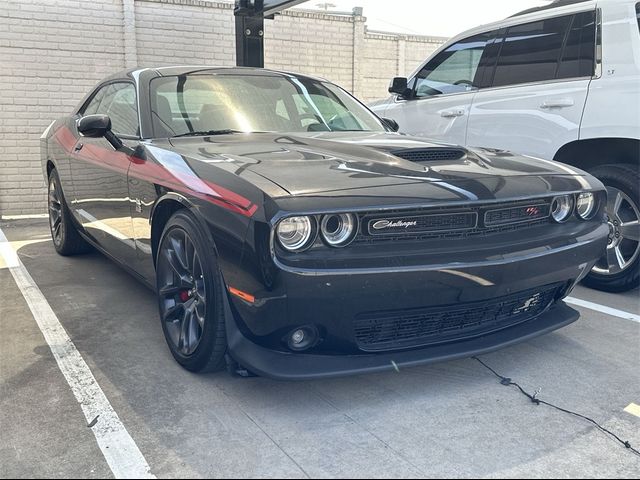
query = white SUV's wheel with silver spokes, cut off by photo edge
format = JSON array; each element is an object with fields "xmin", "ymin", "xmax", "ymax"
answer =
[{"xmin": 584, "ymin": 165, "xmax": 640, "ymax": 293}]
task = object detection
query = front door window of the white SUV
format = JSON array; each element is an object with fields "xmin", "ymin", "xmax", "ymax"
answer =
[{"xmin": 415, "ymin": 32, "xmax": 495, "ymax": 98}]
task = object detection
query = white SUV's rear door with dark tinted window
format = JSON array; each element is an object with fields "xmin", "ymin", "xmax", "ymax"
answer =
[{"xmin": 467, "ymin": 10, "xmax": 596, "ymax": 159}]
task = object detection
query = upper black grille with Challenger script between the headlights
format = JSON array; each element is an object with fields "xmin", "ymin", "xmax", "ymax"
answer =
[{"xmin": 354, "ymin": 199, "xmax": 551, "ymax": 245}]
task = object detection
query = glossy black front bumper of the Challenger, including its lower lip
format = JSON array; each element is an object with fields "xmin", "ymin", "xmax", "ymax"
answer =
[{"xmin": 226, "ymin": 225, "xmax": 607, "ymax": 380}]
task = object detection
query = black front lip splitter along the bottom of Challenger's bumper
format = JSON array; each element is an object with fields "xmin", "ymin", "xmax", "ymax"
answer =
[{"xmin": 227, "ymin": 302, "xmax": 579, "ymax": 380}]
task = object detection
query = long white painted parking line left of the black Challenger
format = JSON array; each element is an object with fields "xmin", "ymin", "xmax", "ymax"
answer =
[{"xmin": 0, "ymin": 229, "xmax": 156, "ymax": 478}]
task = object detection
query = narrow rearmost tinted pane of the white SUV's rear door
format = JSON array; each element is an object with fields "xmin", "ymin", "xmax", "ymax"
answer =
[{"xmin": 556, "ymin": 11, "xmax": 596, "ymax": 78}]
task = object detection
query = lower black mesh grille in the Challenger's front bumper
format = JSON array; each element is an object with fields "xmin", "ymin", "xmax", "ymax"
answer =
[{"xmin": 354, "ymin": 284, "xmax": 564, "ymax": 351}]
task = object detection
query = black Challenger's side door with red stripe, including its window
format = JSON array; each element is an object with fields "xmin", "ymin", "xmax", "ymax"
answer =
[{"xmin": 71, "ymin": 81, "xmax": 139, "ymax": 263}]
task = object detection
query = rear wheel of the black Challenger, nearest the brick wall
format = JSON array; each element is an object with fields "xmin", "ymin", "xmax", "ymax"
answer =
[{"xmin": 47, "ymin": 169, "xmax": 91, "ymax": 256}]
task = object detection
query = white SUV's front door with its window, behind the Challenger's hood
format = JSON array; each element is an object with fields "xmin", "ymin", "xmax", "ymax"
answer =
[{"xmin": 384, "ymin": 32, "xmax": 495, "ymax": 144}]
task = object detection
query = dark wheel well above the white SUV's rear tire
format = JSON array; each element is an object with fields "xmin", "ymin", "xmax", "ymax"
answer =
[{"xmin": 553, "ymin": 138, "xmax": 640, "ymax": 171}]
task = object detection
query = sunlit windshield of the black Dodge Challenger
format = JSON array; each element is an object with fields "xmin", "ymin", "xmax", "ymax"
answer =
[{"xmin": 151, "ymin": 73, "xmax": 385, "ymax": 137}]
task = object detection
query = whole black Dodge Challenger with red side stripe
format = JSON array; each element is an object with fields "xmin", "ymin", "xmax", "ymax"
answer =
[{"xmin": 41, "ymin": 67, "xmax": 609, "ymax": 379}]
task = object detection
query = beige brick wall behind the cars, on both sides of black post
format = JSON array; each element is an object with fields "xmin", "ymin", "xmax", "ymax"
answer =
[{"xmin": 0, "ymin": 0, "xmax": 442, "ymax": 215}]
